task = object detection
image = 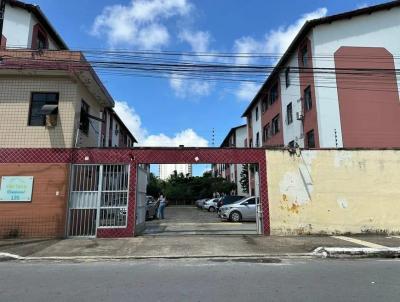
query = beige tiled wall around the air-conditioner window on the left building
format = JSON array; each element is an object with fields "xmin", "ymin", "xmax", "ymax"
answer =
[{"xmin": 0, "ymin": 76, "xmax": 78, "ymax": 148}]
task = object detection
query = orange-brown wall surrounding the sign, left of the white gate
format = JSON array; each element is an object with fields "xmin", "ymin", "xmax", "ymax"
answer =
[{"xmin": 0, "ymin": 164, "xmax": 69, "ymax": 238}]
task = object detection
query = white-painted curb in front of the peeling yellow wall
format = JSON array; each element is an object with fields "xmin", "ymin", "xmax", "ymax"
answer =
[{"xmin": 312, "ymin": 247, "xmax": 400, "ymax": 258}]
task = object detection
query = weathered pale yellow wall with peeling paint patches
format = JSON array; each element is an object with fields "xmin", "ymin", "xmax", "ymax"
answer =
[{"xmin": 266, "ymin": 150, "xmax": 400, "ymax": 235}]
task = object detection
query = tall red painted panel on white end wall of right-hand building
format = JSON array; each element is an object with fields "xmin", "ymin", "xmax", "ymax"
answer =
[{"xmin": 335, "ymin": 47, "xmax": 400, "ymax": 148}]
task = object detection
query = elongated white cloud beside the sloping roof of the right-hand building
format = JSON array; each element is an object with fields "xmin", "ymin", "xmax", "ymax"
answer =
[{"xmin": 265, "ymin": 8, "xmax": 328, "ymax": 54}]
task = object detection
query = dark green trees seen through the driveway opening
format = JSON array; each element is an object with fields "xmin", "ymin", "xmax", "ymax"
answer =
[{"xmin": 147, "ymin": 173, "xmax": 236, "ymax": 201}]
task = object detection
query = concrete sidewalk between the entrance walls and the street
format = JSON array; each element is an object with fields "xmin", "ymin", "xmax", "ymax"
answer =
[{"xmin": 0, "ymin": 235, "xmax": 400, "ymax": 260}]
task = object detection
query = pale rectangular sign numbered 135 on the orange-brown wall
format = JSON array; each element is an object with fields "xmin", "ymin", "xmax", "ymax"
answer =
[{"xmin": 0, "ymin": 176, "xmax": 33, "ymax": 202}]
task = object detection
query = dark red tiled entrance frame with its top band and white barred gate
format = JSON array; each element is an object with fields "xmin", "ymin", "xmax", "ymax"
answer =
[{"xmin": 0, "ymin": 148, "xmax": 270, "ymax": 238}]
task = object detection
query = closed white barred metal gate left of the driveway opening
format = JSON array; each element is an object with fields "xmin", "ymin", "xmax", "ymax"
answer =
[{"xmin": 68, "ymin": 165, "xmax": 129, "ymax": 237}]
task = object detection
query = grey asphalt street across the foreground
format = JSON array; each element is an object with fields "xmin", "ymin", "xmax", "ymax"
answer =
[{"xmin": 0, "ymin": 258, "xmax": 400, "ymax": 302}]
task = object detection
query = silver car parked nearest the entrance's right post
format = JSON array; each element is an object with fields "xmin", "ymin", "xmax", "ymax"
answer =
[{"xmin": 220, "ymin": 196, "xmax": 258, "ymax": 222}]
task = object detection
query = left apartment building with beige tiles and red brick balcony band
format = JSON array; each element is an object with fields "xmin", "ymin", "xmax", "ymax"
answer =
[{"xmin": 0, "ymin": 0, "xmax": 136, "ymax": 148}]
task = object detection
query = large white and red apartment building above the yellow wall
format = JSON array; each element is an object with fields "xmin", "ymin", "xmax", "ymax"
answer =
[{"xmin": 243, "ymin": 1, "xmax": 400, "ymax": 148}]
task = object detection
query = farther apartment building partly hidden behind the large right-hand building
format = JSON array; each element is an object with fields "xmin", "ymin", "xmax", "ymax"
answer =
[{"xmin": 212, "ymin": 125, "xmax": 248, "ymax": 196}]
